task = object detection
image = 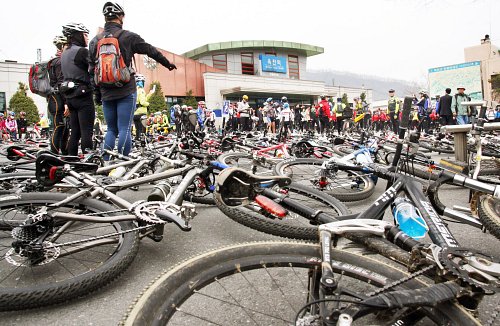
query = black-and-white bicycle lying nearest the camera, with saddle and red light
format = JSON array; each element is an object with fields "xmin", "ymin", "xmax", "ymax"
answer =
[{"xmin": 123, "ymin": 162, "xmax": 500, "ymax": 325}]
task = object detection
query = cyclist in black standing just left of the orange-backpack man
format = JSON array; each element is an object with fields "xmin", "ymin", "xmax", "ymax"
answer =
[{"xmin": 61, "ymin": 23, "xmax": 95, "ymax": 156}]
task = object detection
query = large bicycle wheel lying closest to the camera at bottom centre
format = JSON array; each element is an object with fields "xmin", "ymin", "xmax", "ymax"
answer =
[{"xmin": 122, "ymin": 241, "xmax": 476, "ymax": 326}]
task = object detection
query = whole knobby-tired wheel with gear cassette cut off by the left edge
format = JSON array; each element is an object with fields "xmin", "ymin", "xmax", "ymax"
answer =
[{"xmin": 0, "ymin": 193, "xmax": 139, "ymax": 310}]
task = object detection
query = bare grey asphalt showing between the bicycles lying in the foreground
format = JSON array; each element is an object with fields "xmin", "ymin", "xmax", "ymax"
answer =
[{"xmin": 0, "ymin": 153, "xmax": 500, "ymax": 326}]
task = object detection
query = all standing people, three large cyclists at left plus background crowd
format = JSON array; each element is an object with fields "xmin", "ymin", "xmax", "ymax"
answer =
[{"xmin": 11, "ymin": 2, "xmax": 500, "ymax": 154}]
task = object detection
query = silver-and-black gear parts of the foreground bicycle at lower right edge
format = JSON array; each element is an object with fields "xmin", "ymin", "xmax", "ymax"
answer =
[{"xmin": 439, "ymin": 248, "xmax": 500, "ymax": 292}]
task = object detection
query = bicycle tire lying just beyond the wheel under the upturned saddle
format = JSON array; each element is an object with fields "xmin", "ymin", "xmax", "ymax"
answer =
[{"xmin": 274, "ymin": 158, "xmax": 375, "ymax": 202}]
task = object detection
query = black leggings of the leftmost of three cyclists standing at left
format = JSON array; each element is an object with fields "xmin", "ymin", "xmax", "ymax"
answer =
[{"xmin": 48, "ymin": 94, "xmax": 69, "ymax": 154}]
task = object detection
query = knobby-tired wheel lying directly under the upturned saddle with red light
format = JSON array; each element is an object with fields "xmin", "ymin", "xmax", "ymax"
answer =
[{"xmin": 214, "ymin": 183, "xmax": 349, "ymax": 240}]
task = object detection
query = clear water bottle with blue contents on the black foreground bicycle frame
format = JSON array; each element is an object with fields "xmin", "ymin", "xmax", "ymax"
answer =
[{"xmin": 391, "ymin": 197, "xmax": 429, "ymax": 240}]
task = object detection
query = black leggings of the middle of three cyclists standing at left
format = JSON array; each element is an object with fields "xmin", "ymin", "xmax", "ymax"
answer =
[{"xmin": 67, "ymin": 95, "xmax": 95, "ymax": 155}]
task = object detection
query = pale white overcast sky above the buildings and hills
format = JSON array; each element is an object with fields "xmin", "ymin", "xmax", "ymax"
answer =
[{"xmin": 0, "ymin": 0, "xmax": 500, "ymax": 82}]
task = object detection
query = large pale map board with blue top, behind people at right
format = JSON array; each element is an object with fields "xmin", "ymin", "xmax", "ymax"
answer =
[{"xmin": 429, "ymin": 61, "xmax": 483, "ymax": 100}]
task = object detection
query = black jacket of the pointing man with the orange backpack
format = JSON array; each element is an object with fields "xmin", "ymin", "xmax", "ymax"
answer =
[{"xmin": 89, "ymin": 22, "xmax": 174, "ymax": 101}]
